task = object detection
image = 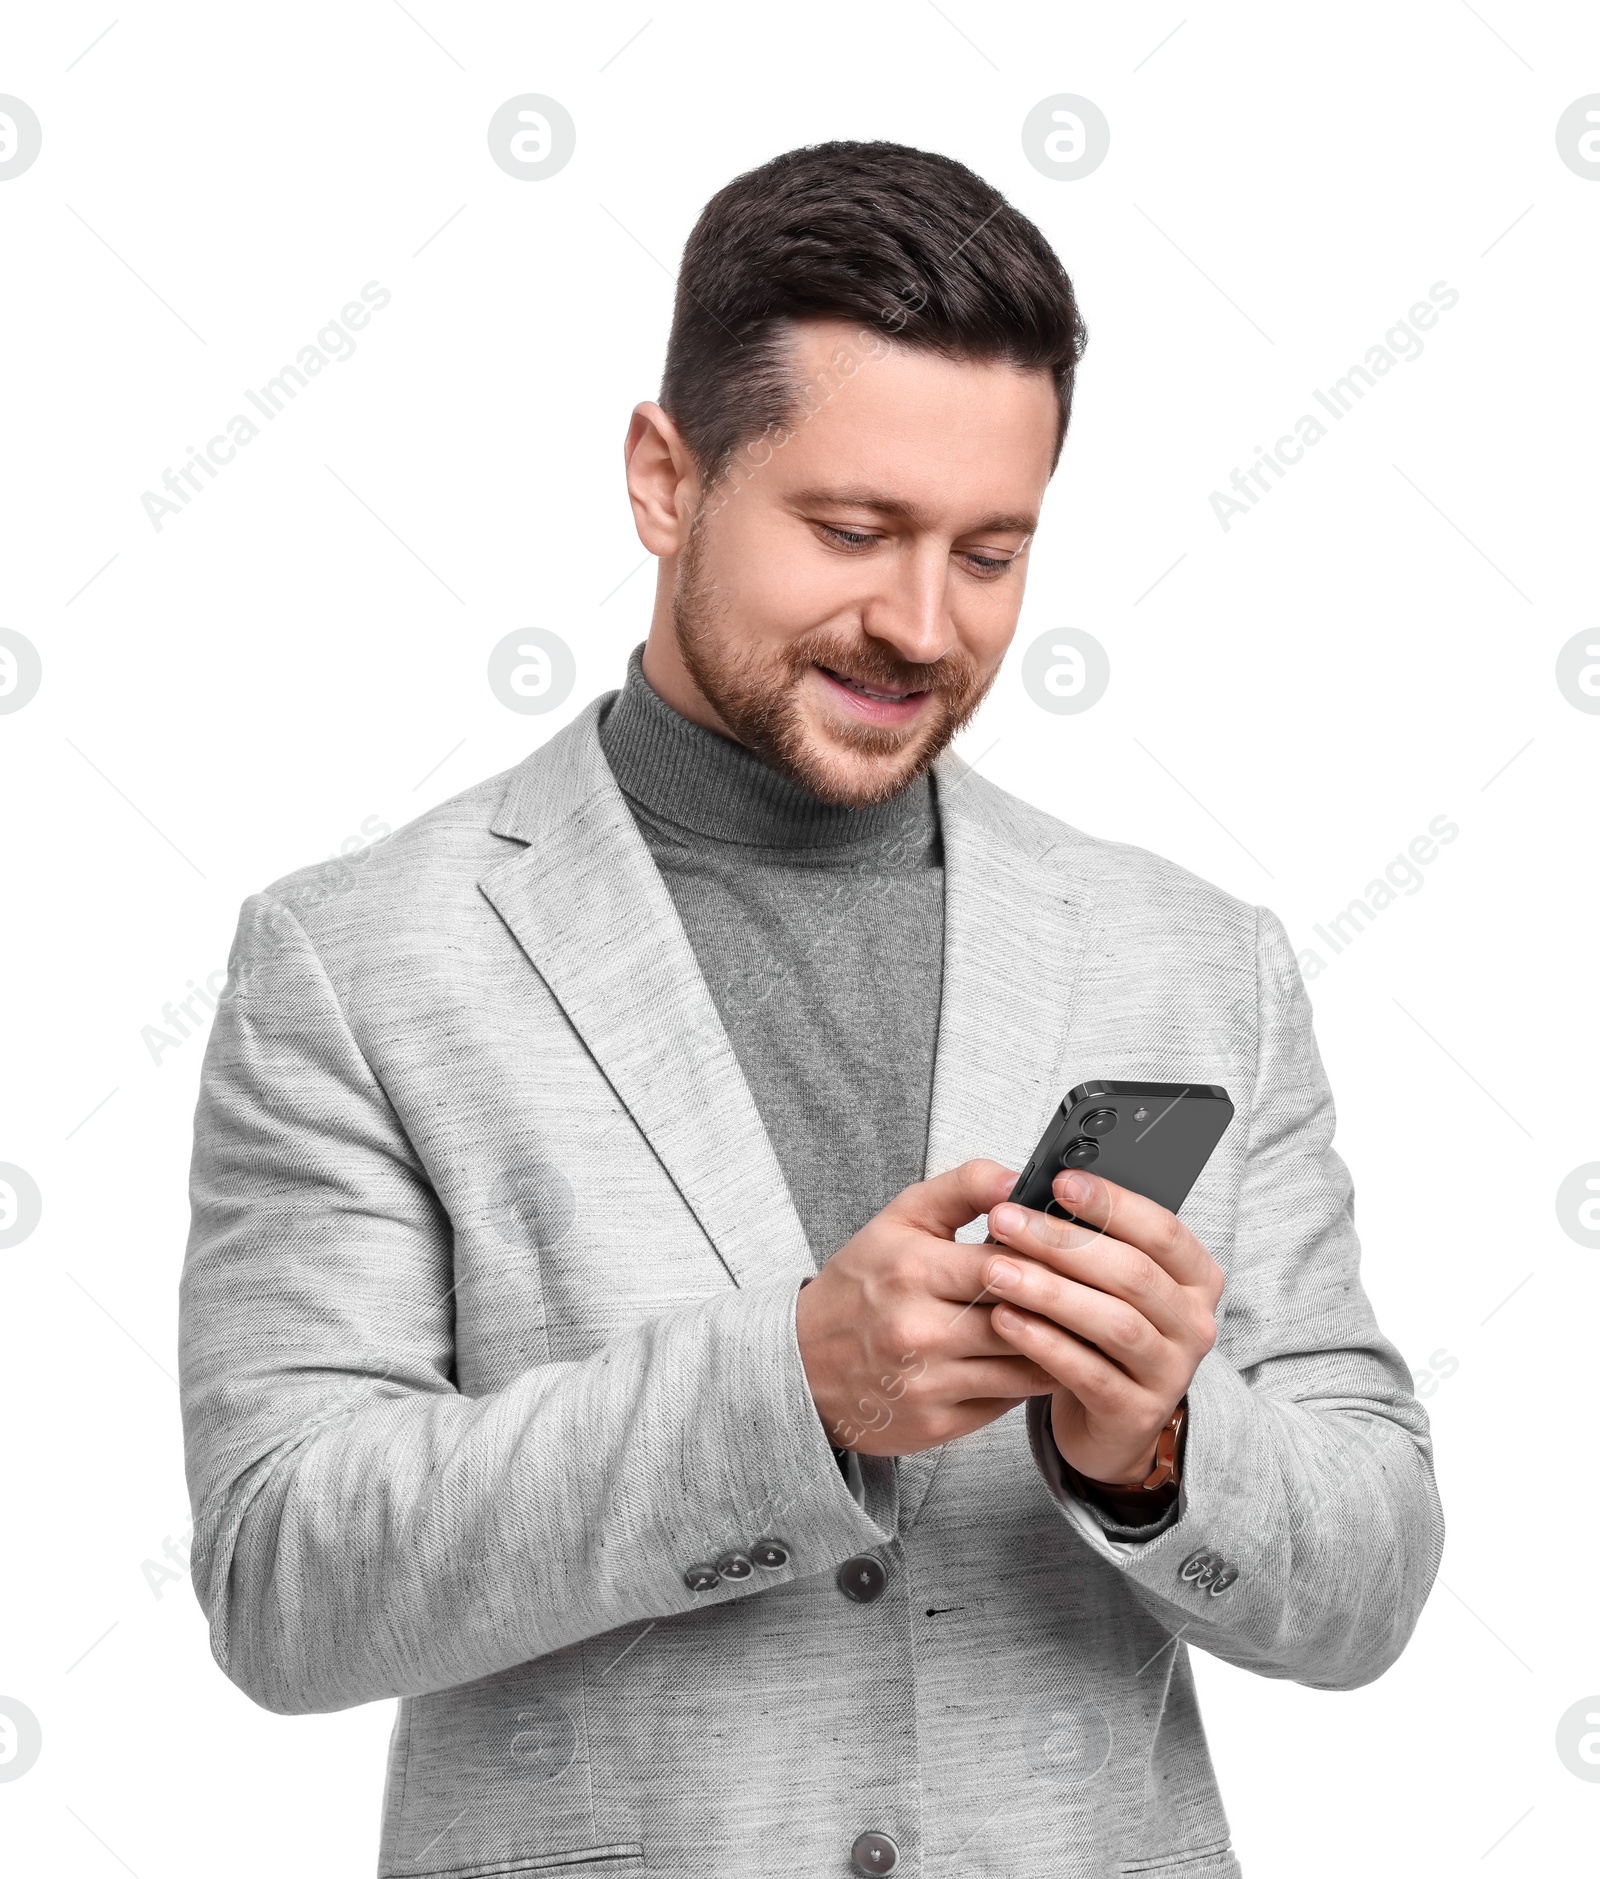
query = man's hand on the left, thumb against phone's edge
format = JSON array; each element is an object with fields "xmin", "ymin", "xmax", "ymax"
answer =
[{"xmin": 794, "ymin": 1161, "xmax": 1059, "ymax": 1454}]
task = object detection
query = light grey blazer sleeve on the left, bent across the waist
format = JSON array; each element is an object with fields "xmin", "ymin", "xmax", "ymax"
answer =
[{"xmin": 178, "ymin": 896, "xmax": 894, "ymax": 1714}]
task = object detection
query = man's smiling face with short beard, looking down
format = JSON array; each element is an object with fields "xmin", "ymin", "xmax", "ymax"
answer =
[{"xmin": 657, "ymin": 321, "xmax": 1057, "ymax": 806}]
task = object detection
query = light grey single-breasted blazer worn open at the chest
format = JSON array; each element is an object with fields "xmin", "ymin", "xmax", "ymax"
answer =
[{"xmin": 180, "ymin": 699, "xmax": 1442, "ymax": 1879}]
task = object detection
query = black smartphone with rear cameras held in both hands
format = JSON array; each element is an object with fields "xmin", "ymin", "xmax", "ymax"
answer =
[{"xmin": 1010, "ymin": 1082, "xmax": 1234, "ymax": 1231}]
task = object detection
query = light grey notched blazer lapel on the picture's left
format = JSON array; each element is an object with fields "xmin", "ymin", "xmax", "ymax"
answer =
[{"xmin": 479, "ymin": 693, "xmax": 817, "ymax": 1285}]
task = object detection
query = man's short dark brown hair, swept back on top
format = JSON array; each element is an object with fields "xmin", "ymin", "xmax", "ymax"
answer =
[{"xmin": 659, "ymin": 143, "xmax": 1087, "ymax": 485}]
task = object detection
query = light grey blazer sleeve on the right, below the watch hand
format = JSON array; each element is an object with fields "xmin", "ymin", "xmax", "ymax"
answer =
[{"xmin": 1027, "ymin": 908, "xmax": 1444, "ymax": 1689}]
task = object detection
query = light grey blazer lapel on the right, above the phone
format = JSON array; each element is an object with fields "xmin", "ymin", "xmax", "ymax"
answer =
[{"xmin": 898, "ymin": 750, "xmax": 1091, "ymax": 1528}]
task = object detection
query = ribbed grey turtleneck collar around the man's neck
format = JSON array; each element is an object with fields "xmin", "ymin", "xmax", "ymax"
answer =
[{"xmin": 599, "ymin": 643, "xmax": 939, "ymax": 853}]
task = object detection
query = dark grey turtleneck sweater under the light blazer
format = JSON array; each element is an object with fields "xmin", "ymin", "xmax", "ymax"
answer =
[{"xmin": 599, "ymin": 646, "xmax": 945, "ymax": 1265}]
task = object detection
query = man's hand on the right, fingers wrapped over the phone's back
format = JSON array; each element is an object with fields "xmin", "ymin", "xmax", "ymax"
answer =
[{"xmin": 980, "ymin": 1169, "xmax": 1223, "ymax": 1486}]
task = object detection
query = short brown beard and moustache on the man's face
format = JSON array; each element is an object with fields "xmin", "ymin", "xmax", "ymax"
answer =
[{"xmin": 672, "ymin": 532, "xmax": 999, "ymax": 808}]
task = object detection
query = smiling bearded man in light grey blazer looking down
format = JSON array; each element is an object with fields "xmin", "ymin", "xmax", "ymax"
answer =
[{"xmin": 182, "ymin": 143, "xmax": 1442, "ymax": 1879}]
